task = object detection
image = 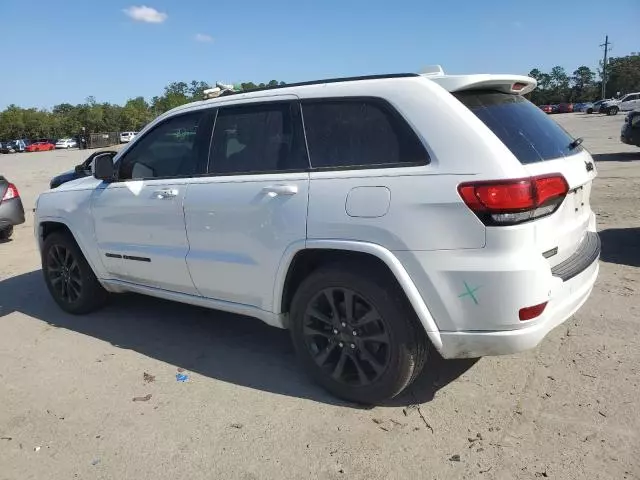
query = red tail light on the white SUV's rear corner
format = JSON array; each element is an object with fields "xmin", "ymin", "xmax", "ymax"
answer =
[{"xmin": 458, "ymin": 174, "xmax": 569, "ymax": 226}]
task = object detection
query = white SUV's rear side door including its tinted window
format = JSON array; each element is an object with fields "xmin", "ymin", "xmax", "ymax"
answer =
[{"xmin": 185, "ymin": 96, "xmax": 309, "ymax": 311}]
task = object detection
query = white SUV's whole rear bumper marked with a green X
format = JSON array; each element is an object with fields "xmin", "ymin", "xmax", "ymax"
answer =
[{"xmin": 394, "ymin": 223, "xmax": 600, "ymax": 358}]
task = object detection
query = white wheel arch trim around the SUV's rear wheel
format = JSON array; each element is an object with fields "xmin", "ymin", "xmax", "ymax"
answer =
[{"xmin": 273, "ymin": 240, "xmax": 442, "ymax": 350}]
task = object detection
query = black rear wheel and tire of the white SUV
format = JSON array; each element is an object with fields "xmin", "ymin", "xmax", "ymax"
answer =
[{"xmin": 291, "ymin": 264, "xmax": 430, "ymax": 404}]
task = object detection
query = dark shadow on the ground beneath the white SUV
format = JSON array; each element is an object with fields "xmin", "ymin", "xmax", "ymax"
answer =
[{"xmin": 0, "ymin": 270, "xmax": 475, "ymax": 408}]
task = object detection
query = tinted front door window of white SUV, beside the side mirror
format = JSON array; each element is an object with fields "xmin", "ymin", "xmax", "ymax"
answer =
[{"xmin": 119, "ymin": 111, "xmax": 210, "ymax": 179}]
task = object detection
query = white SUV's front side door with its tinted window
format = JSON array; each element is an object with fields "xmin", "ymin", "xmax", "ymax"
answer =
[{"xmin": 92, "ymin": 111, "xmax": 211, "ymax": 294}]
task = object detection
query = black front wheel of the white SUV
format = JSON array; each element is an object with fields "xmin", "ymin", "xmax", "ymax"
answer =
[{"xmin": 42, "ymin": 232, "xmax": 108, "ymax": 315}]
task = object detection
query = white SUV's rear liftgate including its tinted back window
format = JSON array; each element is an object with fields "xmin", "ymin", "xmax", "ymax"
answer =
[{"xmin": 455, "ymin": 90, "xmax": 596, "ymax": 267}]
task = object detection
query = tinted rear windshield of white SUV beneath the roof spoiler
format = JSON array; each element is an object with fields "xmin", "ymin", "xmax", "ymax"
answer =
[{"xmin": 454, "ymin": 91, "xmax": 581, "ymax": 164}]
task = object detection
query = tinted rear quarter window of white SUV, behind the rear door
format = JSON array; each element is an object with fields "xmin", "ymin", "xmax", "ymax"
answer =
[{"xmin": 302, "ymin": 99, "xmax": 428, "ymax": 168}]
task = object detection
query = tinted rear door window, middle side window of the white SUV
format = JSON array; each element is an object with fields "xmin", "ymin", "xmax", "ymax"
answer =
[{"xmin": 209, "ymin": 102, "xmax": 309, "ymax": 174}]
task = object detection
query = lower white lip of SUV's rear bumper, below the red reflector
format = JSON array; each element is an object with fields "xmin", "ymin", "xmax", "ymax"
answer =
[{"xmin": 440, "ymin": 259, "xmax": 600, "ymax": 358}]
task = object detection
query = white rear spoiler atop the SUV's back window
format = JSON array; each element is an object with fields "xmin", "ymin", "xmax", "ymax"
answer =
[{"xmin": 423, "ymin": 74, "xmax": 537, "ymax": 95}]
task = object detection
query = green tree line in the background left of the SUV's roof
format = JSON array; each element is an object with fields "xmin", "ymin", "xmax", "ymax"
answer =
[{"xmin": 0, "ymin": 80, "xmax": 284, "ymax": 141}]
